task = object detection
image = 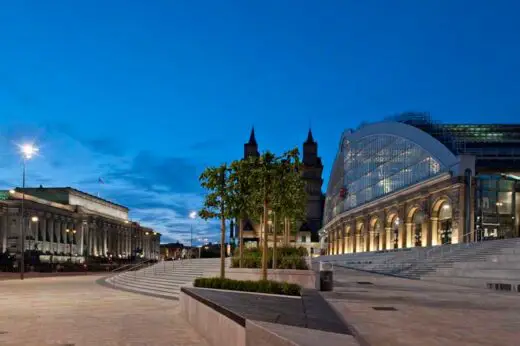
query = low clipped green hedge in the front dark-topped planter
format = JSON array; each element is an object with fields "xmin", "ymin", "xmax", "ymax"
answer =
[{"xmin": 193, "ymin": 278, "xmax": 301, "ymax": 296}]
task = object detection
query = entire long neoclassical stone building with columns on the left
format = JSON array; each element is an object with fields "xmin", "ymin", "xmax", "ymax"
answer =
[{"xmin": 0, "ymin": 187, "xmax": 160, "ymax": 260}]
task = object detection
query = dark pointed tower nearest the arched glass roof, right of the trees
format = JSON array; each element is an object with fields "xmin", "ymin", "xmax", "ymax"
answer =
[{"xmin": 301, "ymin": 129, "xmax": 324, "ymax": 241}]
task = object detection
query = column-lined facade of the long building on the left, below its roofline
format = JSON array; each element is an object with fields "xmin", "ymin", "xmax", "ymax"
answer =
[{"xmin": 0, "ymin": 212, "xmax": 160, "ymax": 259}]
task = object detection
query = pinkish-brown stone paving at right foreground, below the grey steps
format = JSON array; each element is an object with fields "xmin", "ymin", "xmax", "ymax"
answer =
[{"xmin": 322, "ymin": 267, "xmax": 520, "ymax": 346}]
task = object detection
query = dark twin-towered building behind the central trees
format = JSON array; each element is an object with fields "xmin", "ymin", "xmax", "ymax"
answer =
[{"xmin": 237, "ymin": 128, "xmax": 325, "ymax": 253}]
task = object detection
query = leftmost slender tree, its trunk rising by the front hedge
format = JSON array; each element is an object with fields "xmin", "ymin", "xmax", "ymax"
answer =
[{"xmin": 199, "ymin": 164, "xmax": 230, "ymax": 279}]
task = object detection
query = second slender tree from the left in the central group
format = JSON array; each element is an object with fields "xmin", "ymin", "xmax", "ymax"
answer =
[{"xmin": 229, "ymin": 159, "xmax": 254, "ymax": 268}]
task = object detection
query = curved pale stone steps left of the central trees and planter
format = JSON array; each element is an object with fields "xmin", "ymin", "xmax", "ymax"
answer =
[{"xmin": 105, "ymin": 258, "xmax": 220, "ymax": 299}]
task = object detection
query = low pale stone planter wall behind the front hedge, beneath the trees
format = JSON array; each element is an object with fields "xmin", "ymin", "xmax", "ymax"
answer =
[{"xmin": 203, "ymin": 268, "xmax": 316, "ymax": 289}]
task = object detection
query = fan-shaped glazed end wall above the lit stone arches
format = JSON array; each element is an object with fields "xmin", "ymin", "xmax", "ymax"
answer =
[{"xmin": 325, "ymin": 135, "xmax": 444, "ymax": 222}]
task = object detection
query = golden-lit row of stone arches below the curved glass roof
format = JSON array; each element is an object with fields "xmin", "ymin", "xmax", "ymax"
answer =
[{"xmin": 325, "ymin": 196, "xmax": 464, "ymax": 255}]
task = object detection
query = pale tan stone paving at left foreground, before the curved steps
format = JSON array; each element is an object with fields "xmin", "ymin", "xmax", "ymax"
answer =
[{"xmin": 0, "ymin": 275, "xmax": 208, "ymax": 346}]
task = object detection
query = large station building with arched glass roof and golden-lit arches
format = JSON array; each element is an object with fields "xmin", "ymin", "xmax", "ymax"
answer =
[{"xmin": 320, "ymin": 114, "xmax": 520, "ymax": 255}]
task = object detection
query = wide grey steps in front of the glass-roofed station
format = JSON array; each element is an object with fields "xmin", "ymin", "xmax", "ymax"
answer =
[{"xmin": 318, "ymin": 238, "xmax": 520, "ymax": 291}]
